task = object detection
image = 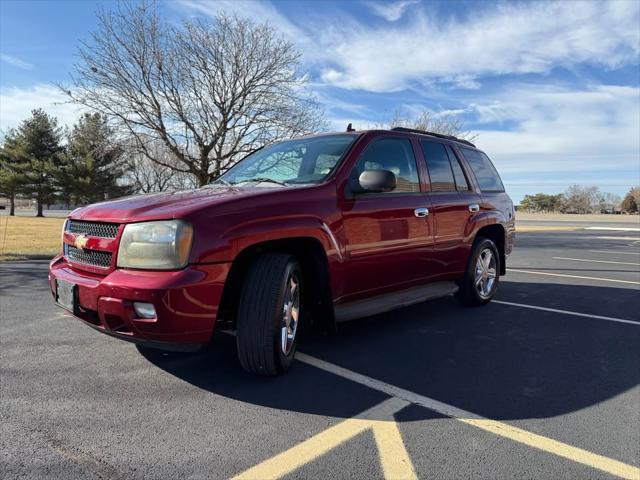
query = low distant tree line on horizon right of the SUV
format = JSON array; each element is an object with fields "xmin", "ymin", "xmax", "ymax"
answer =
[{"xmin": 519, "ymin": 185, "xmax": 640, "ymax": 213}]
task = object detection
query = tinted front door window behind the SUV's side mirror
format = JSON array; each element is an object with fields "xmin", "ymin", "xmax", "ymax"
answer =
[{"xmin": 353, "ymin": 138, "xmax": 420, "ymax": 193}]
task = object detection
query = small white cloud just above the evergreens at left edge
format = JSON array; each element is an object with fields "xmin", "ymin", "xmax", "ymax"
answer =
[{"xmin": 0, "ymin": 84, "xmax": 82, "ymax": 133}]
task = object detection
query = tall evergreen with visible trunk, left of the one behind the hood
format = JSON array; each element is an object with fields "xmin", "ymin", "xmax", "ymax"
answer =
[{"xmin": 11, "ymin": 109, "xmax": 62, "ymax": 217}]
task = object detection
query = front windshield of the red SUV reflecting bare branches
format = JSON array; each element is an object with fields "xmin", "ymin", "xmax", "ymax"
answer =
[{"xmin": 214, "ymin": 135, "xmax": 356, "ymax": 185}]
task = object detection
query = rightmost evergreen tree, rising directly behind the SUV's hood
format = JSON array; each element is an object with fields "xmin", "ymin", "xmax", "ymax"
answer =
[{"xmin": 57, "ymin": 113, "xmax": 130, "ymax": 204}]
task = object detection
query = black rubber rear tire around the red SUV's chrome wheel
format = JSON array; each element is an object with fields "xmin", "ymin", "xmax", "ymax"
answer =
[{"xmin": 456, "ymin": 238, "xmax": 500, "ymax": 306}]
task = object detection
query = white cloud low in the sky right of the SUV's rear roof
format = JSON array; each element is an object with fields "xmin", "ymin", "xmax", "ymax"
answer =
[{"xmin": 471, "ymin": 85, "xmax": 640, "ymax": 177}]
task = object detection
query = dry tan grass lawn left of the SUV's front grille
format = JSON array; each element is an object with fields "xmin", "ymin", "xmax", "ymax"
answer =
[{"xmin": 0, "ymin": 215, "xmax": 64, "ymax": 261}]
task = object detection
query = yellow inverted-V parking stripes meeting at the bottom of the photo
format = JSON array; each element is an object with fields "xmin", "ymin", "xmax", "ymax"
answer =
[{"xmin": 233, "ymin": 398, "xmax": 417, "ymax": 480}]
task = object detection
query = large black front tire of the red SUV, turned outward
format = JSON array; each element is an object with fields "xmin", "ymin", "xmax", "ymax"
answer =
[{"xmin": 236, "ymin": 253, "xmax": 303, "ymax": 375}]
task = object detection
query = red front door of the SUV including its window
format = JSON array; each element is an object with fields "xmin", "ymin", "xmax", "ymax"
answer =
[{"xmin": 342, "ymin": 136, "xmax": 435, "ymax": 300}]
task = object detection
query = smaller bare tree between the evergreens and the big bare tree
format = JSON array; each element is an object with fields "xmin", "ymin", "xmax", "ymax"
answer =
[{"xmin": 126, "ymin": 142, "xmax": 198, "ymax": 193}]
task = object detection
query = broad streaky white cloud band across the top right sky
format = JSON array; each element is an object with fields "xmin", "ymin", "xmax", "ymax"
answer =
[{"xmin": 319, "ymin": 1, "xmax": 640, "ymax": 91}]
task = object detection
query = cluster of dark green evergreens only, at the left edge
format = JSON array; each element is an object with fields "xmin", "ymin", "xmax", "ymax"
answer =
[{"xmin": 0, "ymin": 109, "xmax": 133, "ymax": 216}]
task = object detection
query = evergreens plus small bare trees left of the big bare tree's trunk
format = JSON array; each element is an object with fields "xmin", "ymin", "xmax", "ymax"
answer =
[{"xmin": 0, "ymin": 109, "xmax": 205, "ymax": 216}]
